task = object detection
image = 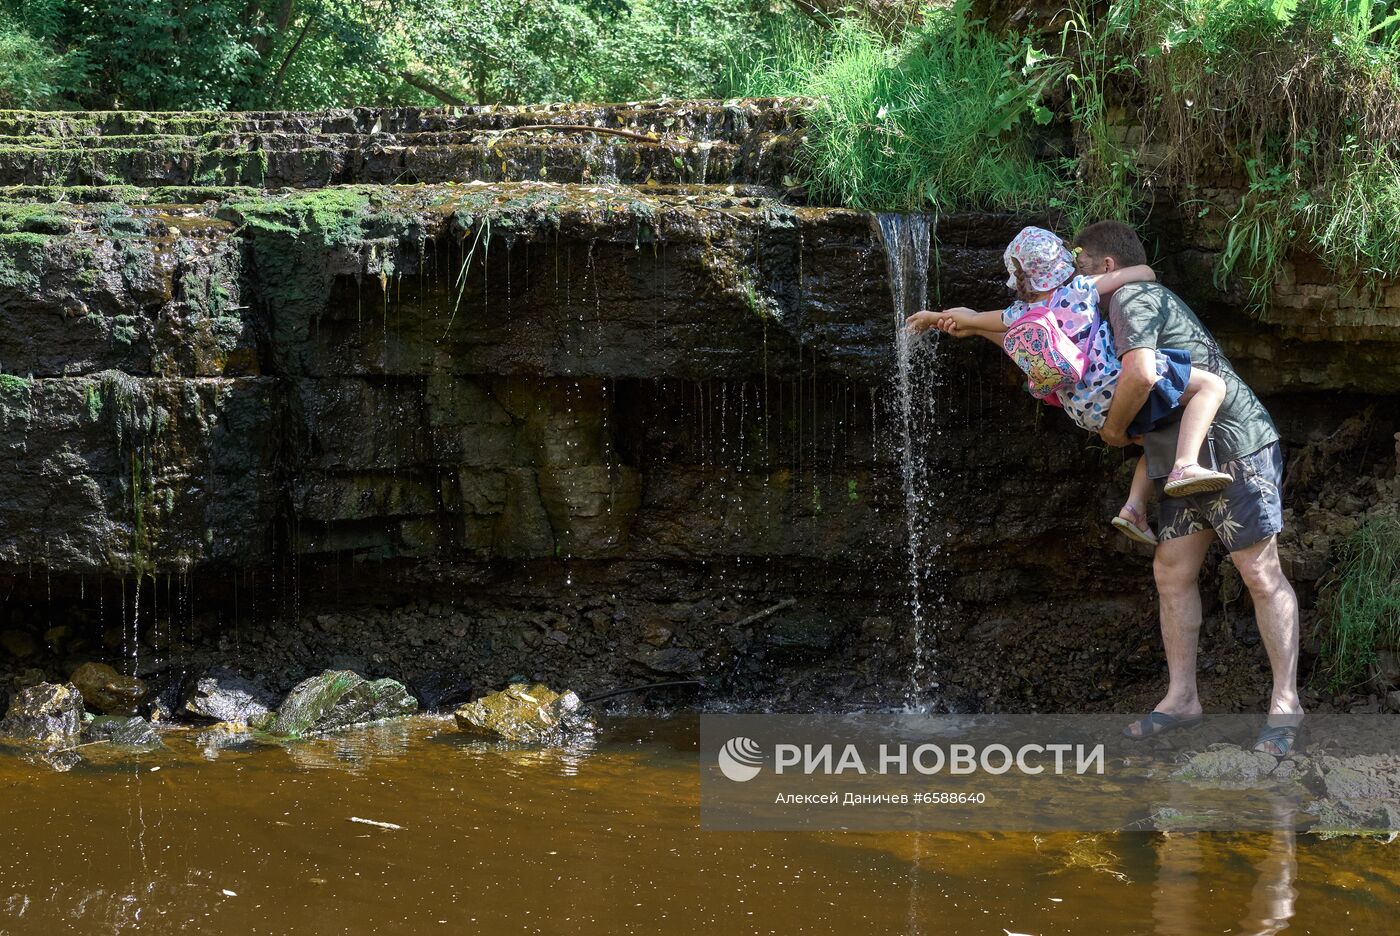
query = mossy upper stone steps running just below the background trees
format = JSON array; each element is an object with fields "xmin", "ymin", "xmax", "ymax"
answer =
[{"xmin": 0, "ymin": 101, "xmax": 801, "ymax": 187}]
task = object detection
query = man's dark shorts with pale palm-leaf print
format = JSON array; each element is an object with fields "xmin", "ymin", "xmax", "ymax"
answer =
[{"xmin": 1156, "ymin": 442, "xmax": 1284, "ymax": 553}]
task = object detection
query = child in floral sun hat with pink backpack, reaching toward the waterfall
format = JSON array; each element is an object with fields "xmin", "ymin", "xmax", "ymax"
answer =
[{"xmin": 909, "ymin": 227, "xmax": 1231, "ymax": 544}]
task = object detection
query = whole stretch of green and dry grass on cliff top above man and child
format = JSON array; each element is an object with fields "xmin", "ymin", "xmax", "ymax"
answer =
[{"xmin": 732, "ymin": 0, "xmax": 1400, "ymax": 302}]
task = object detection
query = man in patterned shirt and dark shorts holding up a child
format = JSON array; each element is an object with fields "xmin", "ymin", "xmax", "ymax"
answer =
[{"xmin": 1075, "ymin": 221, "xmax": 1302, "ymax": 756}]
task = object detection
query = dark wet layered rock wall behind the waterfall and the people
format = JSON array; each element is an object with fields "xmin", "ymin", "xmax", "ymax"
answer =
[{"xmin": 0, "ymin": 102, "xmax": 1400, "ymax": 707}]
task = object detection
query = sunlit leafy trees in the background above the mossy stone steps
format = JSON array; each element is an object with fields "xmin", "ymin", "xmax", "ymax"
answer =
[{"xmin": 0, "ymin": 0, "xmax": 762, "ymax": 111}]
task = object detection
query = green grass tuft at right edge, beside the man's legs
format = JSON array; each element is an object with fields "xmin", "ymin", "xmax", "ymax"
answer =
[{"xmin": 1320, "ymin": 515, "xmax": 1400, "ymax": 690}]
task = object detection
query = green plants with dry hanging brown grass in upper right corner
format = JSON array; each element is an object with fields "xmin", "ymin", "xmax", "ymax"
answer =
[{"xmin": 1105, "ymin": 0, "xmax": 1400, "ymax": 304}]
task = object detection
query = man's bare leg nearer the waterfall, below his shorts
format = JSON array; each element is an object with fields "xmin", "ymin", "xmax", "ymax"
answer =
[{"xmin": 1133, "ymin": 529, "xmax": 1215, "ymax": 733}]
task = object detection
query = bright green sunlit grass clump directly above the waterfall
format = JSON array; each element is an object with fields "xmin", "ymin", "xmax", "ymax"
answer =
[{"xmin": 738, "ymin": 4, "xmax": 1056, "ymax": 210}]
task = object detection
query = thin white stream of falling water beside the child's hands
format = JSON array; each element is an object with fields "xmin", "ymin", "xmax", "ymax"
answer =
[{"xmin": 876, "ymin": 213, "xmax": 939, "ymax": 709}]
